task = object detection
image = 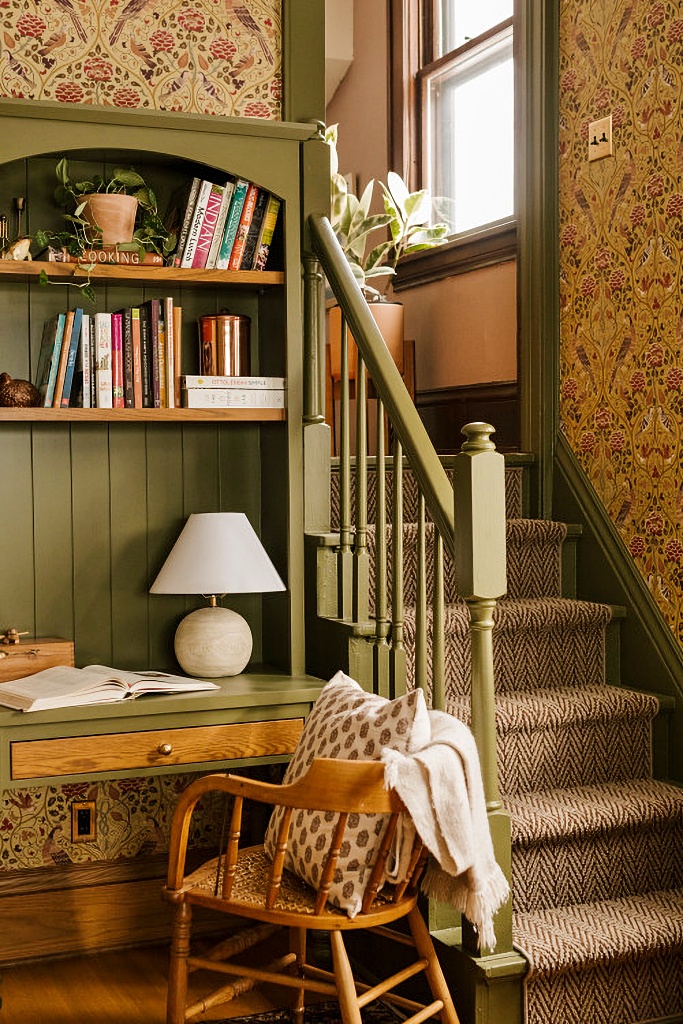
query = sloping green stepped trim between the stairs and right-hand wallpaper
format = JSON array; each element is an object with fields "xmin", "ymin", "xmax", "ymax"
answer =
[{"xmin": 553, "ymin": 436, "xmax": 683, "ymax": 779}]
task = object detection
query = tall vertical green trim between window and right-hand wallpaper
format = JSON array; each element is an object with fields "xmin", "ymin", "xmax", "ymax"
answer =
[{"xmin": 515, "ymin": 0, "xmax": 559, "ymax": 516}]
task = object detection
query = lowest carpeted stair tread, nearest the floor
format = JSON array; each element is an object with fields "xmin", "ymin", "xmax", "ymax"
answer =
[{"xmin": 513, "ymin": 889, "xmax": 683, "ymax": 981}]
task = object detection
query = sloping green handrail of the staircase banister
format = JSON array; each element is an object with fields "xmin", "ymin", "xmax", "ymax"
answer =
[{"xmin": 308, "ymin": 214, "xmax": 454, "ymax": 550}]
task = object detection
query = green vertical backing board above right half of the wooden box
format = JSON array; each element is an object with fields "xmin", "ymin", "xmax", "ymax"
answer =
[{"xmin": 33, "ymin": 423, "xmax": 74, "ymax": 639}]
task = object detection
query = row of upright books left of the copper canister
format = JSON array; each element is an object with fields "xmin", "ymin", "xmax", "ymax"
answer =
[{"xmin": 35, "ymin": 297, "xmax": 182, "ymax": 409}]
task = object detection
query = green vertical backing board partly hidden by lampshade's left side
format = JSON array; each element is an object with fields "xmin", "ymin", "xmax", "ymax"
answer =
[{"xmin": 145, "ymin": 423, "xmax": 185, "ymax": 671}]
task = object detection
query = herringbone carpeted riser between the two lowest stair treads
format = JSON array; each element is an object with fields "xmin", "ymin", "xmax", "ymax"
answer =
[{"xmin": 512, "ymin": 820, "xmax": 683, "ymax": 912}]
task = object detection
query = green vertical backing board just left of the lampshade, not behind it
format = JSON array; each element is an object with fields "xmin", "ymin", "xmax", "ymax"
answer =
[{"xmin": 110, "ymin": 424, "xmax": 150, "ymax": 669}]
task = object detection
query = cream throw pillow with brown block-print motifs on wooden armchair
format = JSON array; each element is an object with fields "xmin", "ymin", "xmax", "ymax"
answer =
[{"xmin": 265, "ymin": 672, "xmax": 430, "ymax": 918}]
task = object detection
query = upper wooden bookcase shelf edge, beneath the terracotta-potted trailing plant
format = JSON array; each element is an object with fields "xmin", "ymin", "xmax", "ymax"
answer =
[{"xmin": 0, "ymin": 259, "xmax": 285, "ymax": 288}]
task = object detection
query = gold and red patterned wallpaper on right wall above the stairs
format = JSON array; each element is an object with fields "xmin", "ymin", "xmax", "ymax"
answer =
[{"xmin": 559, "ymin": 0, "xmax": 683, "ymax": 642}]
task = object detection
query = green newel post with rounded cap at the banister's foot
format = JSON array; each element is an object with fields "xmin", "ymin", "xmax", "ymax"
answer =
[{"xmin": 454, "ymin": 423, "xmax": 512, "ymax": 952}]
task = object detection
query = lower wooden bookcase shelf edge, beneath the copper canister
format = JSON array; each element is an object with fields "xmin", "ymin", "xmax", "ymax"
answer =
[{"xmin": 0, "ymin": 407, "xmax": 287, "ymax": 423}]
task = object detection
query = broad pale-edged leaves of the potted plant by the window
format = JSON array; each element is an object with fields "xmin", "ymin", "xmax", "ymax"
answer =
[{"xmin": 325, "ymin": 125, "xmax": 450, "ymax": 299}]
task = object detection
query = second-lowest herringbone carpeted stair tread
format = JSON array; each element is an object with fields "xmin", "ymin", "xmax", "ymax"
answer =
[{"xmin": 505, "ymin": 778, "xmax": 683, "ymax": 845}]
